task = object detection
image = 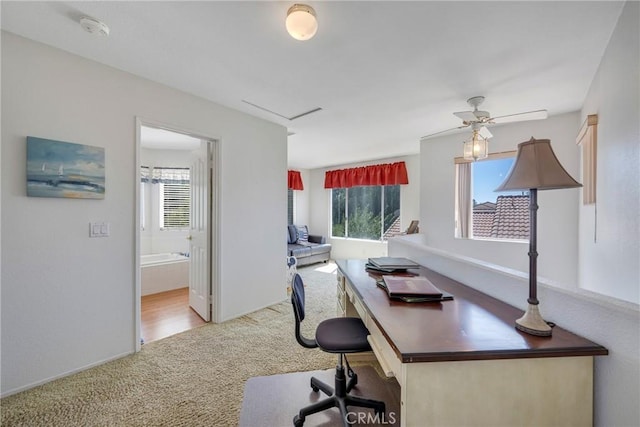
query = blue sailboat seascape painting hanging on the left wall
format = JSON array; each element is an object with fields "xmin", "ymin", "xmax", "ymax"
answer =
[{"xmin": 27, "ymin": 136, "xmax": 105, "ymax": 199}]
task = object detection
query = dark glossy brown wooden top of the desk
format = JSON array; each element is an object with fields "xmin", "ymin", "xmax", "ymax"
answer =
[{"xmin": 337, "ymin": 260, "xmax": 608, "ymax": 363}]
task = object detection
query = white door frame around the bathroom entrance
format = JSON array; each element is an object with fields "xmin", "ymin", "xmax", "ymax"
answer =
[{"xmin": 133, "ymin": 116, "xmax": 222, "ymax": 352}]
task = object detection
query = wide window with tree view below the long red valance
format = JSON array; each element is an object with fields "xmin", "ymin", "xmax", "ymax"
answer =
[{"xmin": 331, "ymin": 185, "xmax": 400, "ymax": 240}]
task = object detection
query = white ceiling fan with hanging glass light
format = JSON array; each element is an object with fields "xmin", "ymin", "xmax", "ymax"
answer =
[{"xmin": 420, "ymin": 96, "xmax": 547, "ymax": 139}]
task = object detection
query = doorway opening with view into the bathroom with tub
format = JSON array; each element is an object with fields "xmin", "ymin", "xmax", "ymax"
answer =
[{"xmin": 136, "ymin": 120, "xmax": 217, "ymax": 350}]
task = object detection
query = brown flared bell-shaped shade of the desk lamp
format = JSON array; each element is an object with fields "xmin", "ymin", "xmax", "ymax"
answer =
[{"xmin": 495, "ymin": 137, "xmax": 582, "ymax": 191}]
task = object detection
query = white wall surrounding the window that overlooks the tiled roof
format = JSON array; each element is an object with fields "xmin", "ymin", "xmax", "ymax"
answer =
[{"xmin": 420, "ymin": 113, "xmax": 580, "ymax": 288}]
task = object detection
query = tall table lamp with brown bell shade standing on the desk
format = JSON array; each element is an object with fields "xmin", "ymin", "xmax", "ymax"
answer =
[{"xmin": 495, "ymin": 137, "xmax": 582, "ymax": 336}]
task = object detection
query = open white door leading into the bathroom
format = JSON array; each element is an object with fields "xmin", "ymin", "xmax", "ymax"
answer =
[{"xmin": 188, "ymin": 141, "xmax": 212, "ymax": 322}]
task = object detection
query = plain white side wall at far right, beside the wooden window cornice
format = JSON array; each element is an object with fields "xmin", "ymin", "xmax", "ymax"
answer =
[{"xmin": 579, "ymin": 2, "xmax": 640, "ymax": 304}]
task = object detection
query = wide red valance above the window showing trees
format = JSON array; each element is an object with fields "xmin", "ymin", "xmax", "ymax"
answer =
[{"xmin": 324, "ymin": 162, "xmax": 409, "ymax": 188}]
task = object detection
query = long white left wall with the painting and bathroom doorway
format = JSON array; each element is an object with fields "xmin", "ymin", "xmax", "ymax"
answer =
[{"xmin": 1, "ymin": 32, "xmax": 287, "ymax": 395}]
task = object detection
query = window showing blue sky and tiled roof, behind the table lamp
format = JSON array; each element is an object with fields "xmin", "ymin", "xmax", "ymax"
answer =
[{"xmin": 455, "ymin": 151, "xmax": 529, "ymax": 240}]
